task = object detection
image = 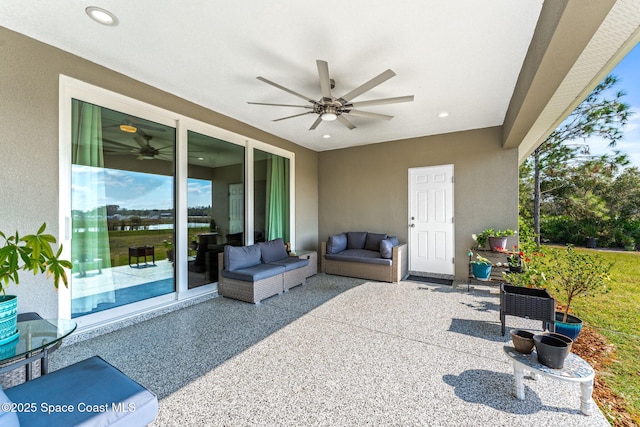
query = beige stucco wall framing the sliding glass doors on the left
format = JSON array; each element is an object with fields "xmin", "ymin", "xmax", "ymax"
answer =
[{"xmin": 0, "ymin": 27, "xmax": 318, "ymax": 317}]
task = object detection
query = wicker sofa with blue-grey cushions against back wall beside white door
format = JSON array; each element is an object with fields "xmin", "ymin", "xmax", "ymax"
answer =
[{"xmin": 320, "ymin": 231, "xmax": 408, "ymax": 283}]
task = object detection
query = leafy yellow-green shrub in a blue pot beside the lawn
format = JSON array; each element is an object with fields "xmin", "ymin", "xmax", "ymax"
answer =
[{"xmin": 550, "ymin": 245, "xmax": 612, "ymax": 340}]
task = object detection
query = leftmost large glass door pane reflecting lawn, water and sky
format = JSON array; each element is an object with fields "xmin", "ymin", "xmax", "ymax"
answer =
[{"xmin": 71, "ymin": 99, "xmax": 176, "ymax": 317}]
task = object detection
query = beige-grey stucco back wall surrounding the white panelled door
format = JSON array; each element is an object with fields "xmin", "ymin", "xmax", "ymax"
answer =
[{"xmin": 319, "ymin": 127, "xmax": 518, "ymax": 279}]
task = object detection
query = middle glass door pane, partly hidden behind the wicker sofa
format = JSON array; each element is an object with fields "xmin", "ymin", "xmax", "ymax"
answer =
[{"xmin": 187, "ymin": 131, "xmax": 245, "ymax": 288}]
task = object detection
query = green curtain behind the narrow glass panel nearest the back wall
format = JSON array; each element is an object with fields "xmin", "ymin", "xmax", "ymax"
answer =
[{"xmin": 266, "ymin": 155, "xmax": 289, "ymax": 242}]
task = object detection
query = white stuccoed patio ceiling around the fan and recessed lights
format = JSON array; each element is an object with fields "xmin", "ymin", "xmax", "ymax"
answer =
[{"xmin": 0, "ymin": 0, "xmax": 543, "ymax": 151}]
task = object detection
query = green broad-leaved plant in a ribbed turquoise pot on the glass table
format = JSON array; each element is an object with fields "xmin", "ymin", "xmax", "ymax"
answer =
[{"xmin": 0, "ymin": 223, "xmax": 73, "ymax": 342}]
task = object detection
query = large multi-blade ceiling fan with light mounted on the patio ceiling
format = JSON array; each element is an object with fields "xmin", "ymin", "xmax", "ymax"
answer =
[{"xmin": 248, "ymin": 59, "xmax": 413, "ymax": 130}]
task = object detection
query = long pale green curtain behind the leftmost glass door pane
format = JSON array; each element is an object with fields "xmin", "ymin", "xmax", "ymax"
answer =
[{"xmin": 71, "ymin": 99, "xmax": 115, "ymax": 313}]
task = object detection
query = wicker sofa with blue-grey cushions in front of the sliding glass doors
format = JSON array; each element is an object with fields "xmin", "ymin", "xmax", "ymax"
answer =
[{"xmin": 218, "ymin": 239, "xmax": 309, "ymax": 304}]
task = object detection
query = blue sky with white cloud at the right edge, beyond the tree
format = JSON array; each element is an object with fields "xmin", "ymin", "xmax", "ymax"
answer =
[{"xmin": 587, "ymin": 44, "xmax": 640, "ymax": 168}]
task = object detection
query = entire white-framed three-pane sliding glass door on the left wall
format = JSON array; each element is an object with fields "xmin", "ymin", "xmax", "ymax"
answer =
[{"xmin": 59, "ymin": 76, "xmax": 295, "ymax": 327}]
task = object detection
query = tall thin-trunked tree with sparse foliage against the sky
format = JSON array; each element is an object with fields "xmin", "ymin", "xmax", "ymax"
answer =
[{"xmin": 521, "ymin": 75, "xmax": 632, "ymax": 244}]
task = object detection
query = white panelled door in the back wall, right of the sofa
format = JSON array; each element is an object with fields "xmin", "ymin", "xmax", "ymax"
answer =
[{"xmin": 409, "ymin": 165, "xmax": 455, "ymax": 275}]
